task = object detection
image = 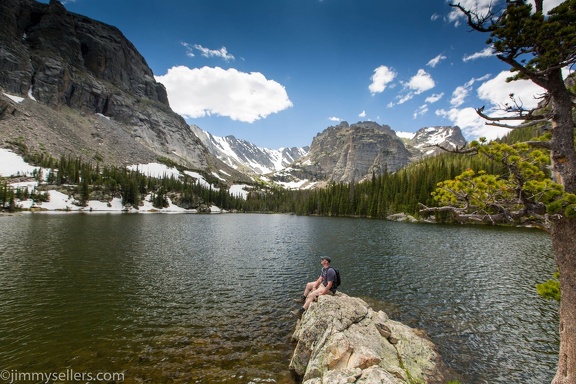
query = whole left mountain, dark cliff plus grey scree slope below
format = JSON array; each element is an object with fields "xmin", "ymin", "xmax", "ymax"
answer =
[{"xmin": 0, "ymin": 0, "xmax": 244, "ymax": 177}]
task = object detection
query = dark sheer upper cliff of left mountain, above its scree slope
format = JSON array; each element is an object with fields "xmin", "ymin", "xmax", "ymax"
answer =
[{"xmin": 0, "ymin": 0, "xmax": 168, "ymax": 108}]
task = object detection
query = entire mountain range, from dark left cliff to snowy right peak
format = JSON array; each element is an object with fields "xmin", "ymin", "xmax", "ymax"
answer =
[{"xmin": 0, "ymin": 0, "xmax": 465, "ymax": 187}]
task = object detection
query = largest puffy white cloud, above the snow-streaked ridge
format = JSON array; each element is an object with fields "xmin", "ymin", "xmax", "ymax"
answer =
[{"xmin": 156, "ymin": 66, "xmax": 292, "ymax": 123}]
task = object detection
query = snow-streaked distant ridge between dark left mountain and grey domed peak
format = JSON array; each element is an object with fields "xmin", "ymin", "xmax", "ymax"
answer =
[{"xmin": 190, "ymin": 125, "xmax": 309, "ymax": 175}]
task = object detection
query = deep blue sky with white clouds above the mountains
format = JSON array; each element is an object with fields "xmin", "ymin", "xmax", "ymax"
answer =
[{"xmin": 43, "ymin": 0, "xmax": 561, "ymax": 149}]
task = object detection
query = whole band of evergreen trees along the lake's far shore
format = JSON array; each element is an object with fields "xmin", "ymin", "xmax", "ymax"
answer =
[{"xmin": 0, "ymin": 131, "xmax": 534, "ymax": 221}]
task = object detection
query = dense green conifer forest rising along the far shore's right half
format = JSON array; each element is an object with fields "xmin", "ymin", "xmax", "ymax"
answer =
[{"xmin": 243, "ymin": 154, "xmax": 502, "ymax": 219}]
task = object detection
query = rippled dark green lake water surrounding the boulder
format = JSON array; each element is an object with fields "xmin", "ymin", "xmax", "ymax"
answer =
[{"xmin": 0, "ymin": 213, "xmax": 558, "ymax": 384}]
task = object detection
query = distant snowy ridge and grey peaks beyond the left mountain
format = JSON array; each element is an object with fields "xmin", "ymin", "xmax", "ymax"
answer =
[{"xmin": 190, "ymin": 121, "xmax": 466, "ymax": 188}]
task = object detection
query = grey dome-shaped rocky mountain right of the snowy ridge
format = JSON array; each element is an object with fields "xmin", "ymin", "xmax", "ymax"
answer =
[{"xmin": 284, "ymin": 121, "xmax": 410, "ymax": 182}]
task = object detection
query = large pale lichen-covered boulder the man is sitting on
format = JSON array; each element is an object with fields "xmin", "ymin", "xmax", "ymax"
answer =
[{"xmin": 290, "ymin": 292, "xmax": 444, "ymax": 384}]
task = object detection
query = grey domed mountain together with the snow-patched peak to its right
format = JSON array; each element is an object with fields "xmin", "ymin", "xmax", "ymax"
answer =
[{"xmin": 264, "ymin": 121, "xmax": 466, "ymax": 188}]
